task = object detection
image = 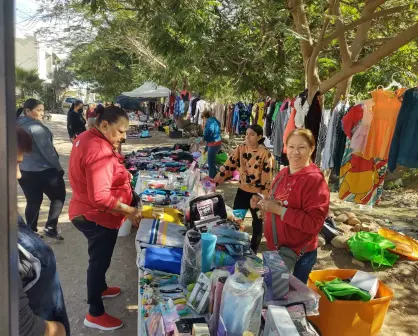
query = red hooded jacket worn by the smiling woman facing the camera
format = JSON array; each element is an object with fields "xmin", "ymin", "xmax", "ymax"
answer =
[{"xmin": 264, "ymin": 164, "xmax": 330, "ymax": 253}]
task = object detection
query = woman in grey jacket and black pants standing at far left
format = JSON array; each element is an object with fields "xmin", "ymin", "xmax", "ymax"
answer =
[{"xmin": 17, "ymin": 98, "xmax": 66, "ymax": 240}]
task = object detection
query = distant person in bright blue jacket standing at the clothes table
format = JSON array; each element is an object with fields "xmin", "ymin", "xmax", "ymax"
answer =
[{"xmin": 202, "ymin": 109, "xmax": 222, "ymax": 178}]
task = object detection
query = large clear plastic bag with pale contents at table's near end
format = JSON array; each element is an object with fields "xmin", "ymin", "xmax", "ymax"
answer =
[{"xmin": 220, "ymin": 273, "xmax": 263, "ymax": 336}]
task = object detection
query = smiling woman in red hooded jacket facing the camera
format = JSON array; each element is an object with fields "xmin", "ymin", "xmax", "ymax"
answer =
[{"xmin": 251, "ymin": 129, "xmax": 330, "ymax": 283}]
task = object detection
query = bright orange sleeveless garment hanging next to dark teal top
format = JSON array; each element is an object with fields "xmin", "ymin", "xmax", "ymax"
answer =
[{"xmin": 364, "ymin": 89, "xmax": 406, "ymax": 160}]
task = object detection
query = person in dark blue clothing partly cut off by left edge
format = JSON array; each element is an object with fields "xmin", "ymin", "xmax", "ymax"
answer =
[{"xmin": 16, "ymin": 127, "xmax": 70, "ymax": 336}]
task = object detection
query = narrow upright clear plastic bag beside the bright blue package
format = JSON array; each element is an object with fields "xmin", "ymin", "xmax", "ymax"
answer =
[{"xmin": 180, "ymin": 230, "xmax": 202, "ymax": 287}]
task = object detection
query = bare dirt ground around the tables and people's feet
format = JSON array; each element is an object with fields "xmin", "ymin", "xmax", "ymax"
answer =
[{"xmin": 18, "ymin": 115, "xmax": 418, "ymax": 336}]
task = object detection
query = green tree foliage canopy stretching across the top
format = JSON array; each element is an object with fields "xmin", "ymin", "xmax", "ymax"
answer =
[{"xmin": 36, "ymin": 0, "xmax": 418, "ymax": 102}]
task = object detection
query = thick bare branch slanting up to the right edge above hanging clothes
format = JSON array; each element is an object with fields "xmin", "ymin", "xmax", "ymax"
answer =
[{"xmin": 319, "ymin": 23, "xmax": 418, "ymax": 94}]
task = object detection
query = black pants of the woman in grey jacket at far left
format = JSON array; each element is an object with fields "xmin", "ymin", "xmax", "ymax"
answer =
[{"xmin": 19, "ymin": 168, "xmax": 66, "ymax": 232}]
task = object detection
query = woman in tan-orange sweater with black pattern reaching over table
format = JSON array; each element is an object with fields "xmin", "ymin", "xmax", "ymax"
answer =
[{"xmin": 214, "ymin": 125, "xmax": 274, "ymax": 253}]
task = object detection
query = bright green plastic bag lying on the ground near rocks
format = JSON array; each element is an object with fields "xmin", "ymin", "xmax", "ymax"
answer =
[{"xmin": 347, "ymin": 232, "xmax": 399, "ymax": 268}]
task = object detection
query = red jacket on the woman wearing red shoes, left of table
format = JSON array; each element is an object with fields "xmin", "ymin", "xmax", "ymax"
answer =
[{"xmin": 68, "ymin": 128, "xmax": 132, "ymax": 229}]
